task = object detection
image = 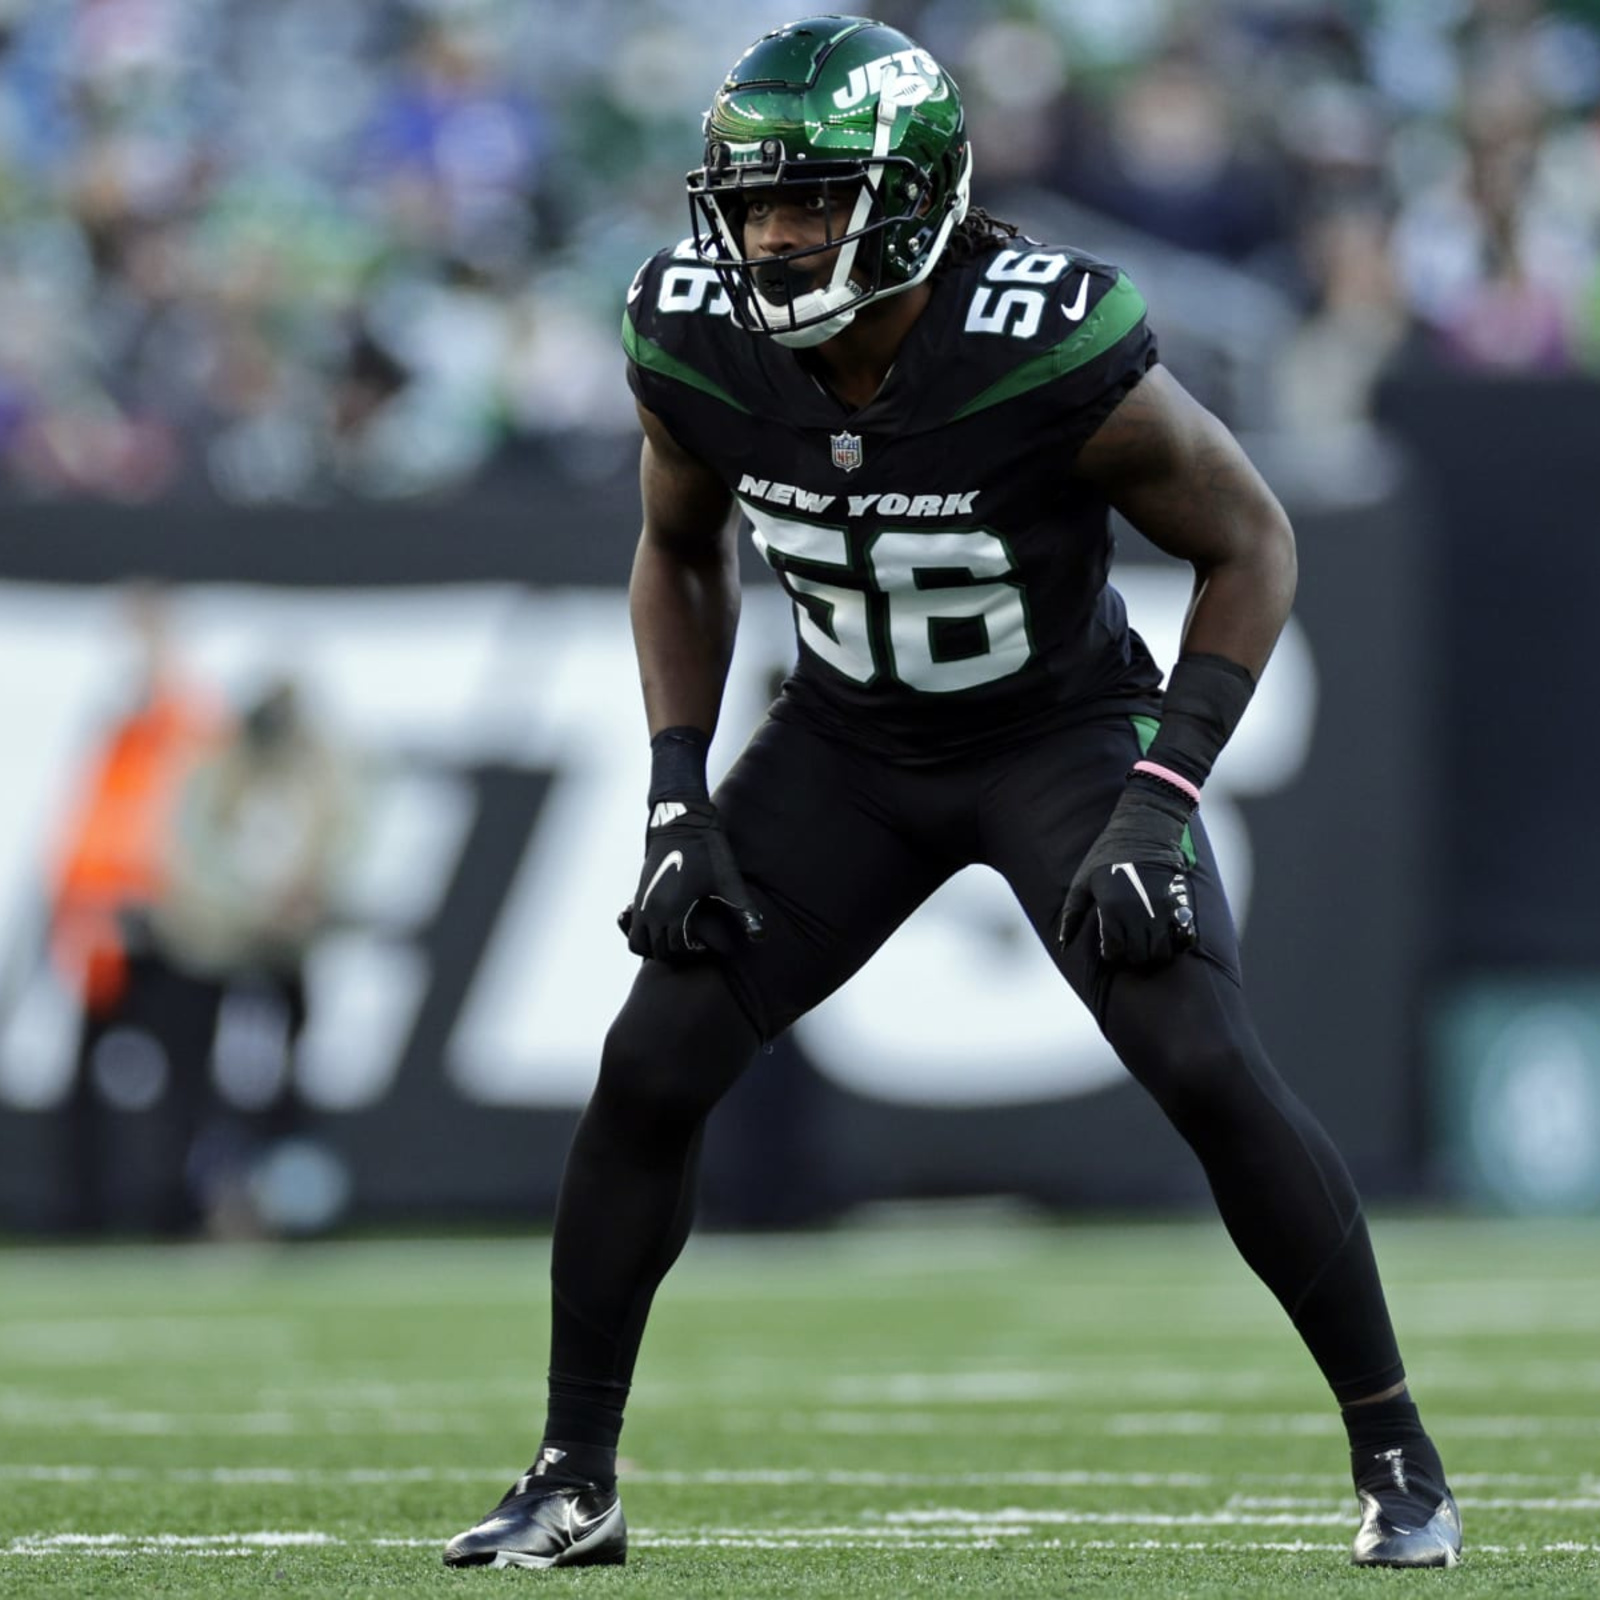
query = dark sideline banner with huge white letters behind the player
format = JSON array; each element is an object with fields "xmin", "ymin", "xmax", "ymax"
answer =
[{"xmin": 0, "ymin": 451, "xmax": 1437, "ymax": 1230}]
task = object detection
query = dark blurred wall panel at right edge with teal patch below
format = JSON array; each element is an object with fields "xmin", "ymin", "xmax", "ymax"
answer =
[{"xmin": 1382, "ymin": 373, "xmax": 1600, "ymax": 1214}]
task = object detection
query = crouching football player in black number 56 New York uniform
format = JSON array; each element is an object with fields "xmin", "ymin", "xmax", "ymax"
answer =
[{"xmin": 445, "ymin": 16, "xmax": 1461, "ymax": 1566}]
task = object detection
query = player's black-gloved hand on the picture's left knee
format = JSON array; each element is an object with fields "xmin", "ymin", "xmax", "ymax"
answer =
[{"xmin": 616, "ymin": 800, "xmax": 765, "ymax": 962}]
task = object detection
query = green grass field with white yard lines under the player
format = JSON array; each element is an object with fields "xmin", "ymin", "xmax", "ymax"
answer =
[{"xmin": 0, "ymin": 1210, "xmax": 1600, "ymax": 1600}]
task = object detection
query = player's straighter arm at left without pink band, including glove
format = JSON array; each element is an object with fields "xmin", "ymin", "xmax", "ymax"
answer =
[{"xmin": 618, "ymin": 406, "xmax": 762, "ymax": 960}]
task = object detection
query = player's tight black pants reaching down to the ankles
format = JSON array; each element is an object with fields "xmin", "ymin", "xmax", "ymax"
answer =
[{"xmin": 550, "ymin": 717, "xmax": 1403, "ymax": 1443}]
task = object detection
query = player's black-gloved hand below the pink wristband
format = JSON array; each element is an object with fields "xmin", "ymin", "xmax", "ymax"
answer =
[{"xmin": 1056, "ymin": 773, "xmax": 1197, "ymax": 968}]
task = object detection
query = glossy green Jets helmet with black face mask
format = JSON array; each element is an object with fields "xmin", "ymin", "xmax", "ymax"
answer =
[{"xmin": 688, "ymin": 16, "xmax": 971, "ymax": 347}]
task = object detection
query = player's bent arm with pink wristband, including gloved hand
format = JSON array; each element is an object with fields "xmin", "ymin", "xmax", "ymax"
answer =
[{"xmin": 1058, "ymin": 366, "xmax": 1296, "ymax": 966}]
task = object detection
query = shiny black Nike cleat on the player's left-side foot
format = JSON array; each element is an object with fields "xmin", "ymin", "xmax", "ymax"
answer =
[{"xmin": 445, "ymin": 1458, "xmax": 627, "ymax": 1566}]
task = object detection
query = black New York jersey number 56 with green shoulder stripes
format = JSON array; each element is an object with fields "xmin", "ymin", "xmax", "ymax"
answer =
[{"xmin": 622, "ymin": 238, "xmax": 1160, "ymax": 762}]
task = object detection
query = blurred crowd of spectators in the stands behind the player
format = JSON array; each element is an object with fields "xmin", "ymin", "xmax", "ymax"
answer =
[{"xmin": 0, "ymin": 0, "xmax": 1600, "ymax": 504}]
